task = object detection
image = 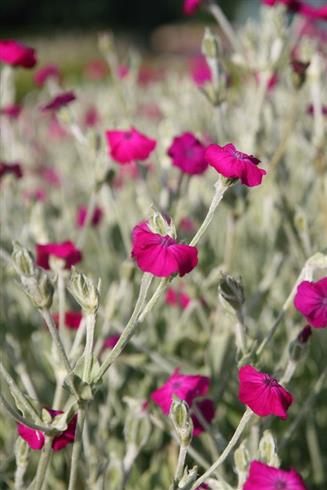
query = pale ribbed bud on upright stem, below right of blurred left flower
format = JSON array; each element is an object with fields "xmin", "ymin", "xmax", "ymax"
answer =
[{"xmin": 69, "ymin": 268, "xmax": 100, "ymax": 313}]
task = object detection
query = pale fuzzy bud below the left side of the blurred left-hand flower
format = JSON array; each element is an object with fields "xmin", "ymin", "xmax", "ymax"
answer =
[{"xmin": 21, "ymin": 268, "xmax": 54, "ymax": 309}]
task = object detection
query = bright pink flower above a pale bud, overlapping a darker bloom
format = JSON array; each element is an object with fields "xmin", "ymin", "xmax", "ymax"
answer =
[{"xmin": 151, "ymin": 368, "xmax": 209, "ymax": 415}]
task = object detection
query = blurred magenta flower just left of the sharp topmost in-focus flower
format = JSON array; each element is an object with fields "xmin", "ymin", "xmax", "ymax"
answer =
[{"xmin": 167, "ymin": 133, "xmax": 208, "ymax": 175}]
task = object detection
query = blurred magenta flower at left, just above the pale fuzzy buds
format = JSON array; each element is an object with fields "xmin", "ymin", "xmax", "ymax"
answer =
[{"xmin": 36, "ymin": 241, "xmax": 82, "ymax": 269}]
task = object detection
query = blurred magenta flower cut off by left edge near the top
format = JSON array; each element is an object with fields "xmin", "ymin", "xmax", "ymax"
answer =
[{"xmin": 0, "ymin": 39, "xmax": 36, "ymax": 68}]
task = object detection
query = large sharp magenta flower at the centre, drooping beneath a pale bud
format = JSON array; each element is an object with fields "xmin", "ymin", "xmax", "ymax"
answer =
[{"xmin": 132, "ymin": 223, "xmax": 198, "ymax": 277}]
